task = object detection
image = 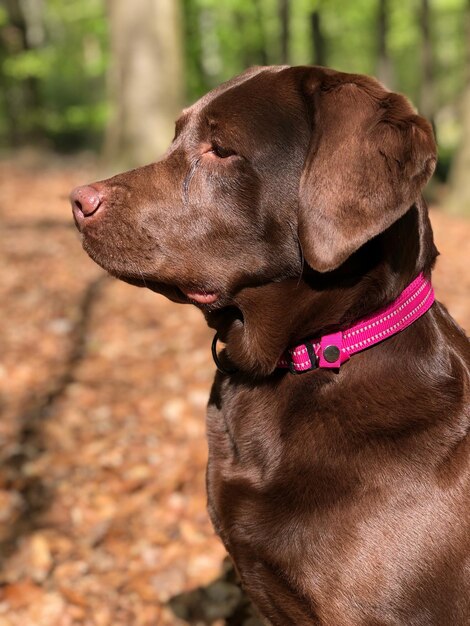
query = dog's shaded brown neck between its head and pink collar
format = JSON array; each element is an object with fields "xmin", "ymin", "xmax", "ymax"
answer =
[{"xmin": 207, "ymin": 202, "xmax": 437, "ymax": 376}]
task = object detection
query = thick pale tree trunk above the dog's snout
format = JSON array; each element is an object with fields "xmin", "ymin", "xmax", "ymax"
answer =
[{"xmin": 105, "ymin": 0, "xmax": 183, "ymax": 166}]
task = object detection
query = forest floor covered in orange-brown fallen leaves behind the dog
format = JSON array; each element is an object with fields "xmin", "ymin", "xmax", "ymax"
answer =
[{"xmin": 0, "ymin": 156, "xmax": 470, "ymax": 626}]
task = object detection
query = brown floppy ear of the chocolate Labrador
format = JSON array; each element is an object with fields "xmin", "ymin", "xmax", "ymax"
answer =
[{"xmin": 299, "ymin": 68, "xmax": 436, "ymax": 272}]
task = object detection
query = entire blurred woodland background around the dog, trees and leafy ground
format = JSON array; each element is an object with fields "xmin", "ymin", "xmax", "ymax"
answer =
[{"xmin": 0, "ymin": 0, "xmax": 470, "ymax": 626}]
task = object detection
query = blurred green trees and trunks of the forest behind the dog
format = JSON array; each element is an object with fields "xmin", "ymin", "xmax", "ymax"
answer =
[{"xmin": 0, "ymin": 0, "xmax": 470, "ymax": 213}]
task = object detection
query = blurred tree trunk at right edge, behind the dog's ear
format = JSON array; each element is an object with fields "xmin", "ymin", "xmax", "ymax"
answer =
[{"xmin": 446, "ymin": 0, "xmax": 470, "ymax": 216}]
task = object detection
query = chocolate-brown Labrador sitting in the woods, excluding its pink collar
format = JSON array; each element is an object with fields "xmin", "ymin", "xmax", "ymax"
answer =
[{"xmin": 72, "ymin": 67, "xmax": 470, "ymax": 626}]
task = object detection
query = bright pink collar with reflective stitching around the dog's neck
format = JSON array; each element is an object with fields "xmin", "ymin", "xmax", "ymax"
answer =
[{"xmin": 278, "ymin": 274, "xmax": 434, "ymax": 374}]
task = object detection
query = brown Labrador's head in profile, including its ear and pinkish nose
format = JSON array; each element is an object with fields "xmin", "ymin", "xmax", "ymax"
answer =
[{"xmin": 72, "ymin": 67, "xmax": 436, "ymax": 368}]
